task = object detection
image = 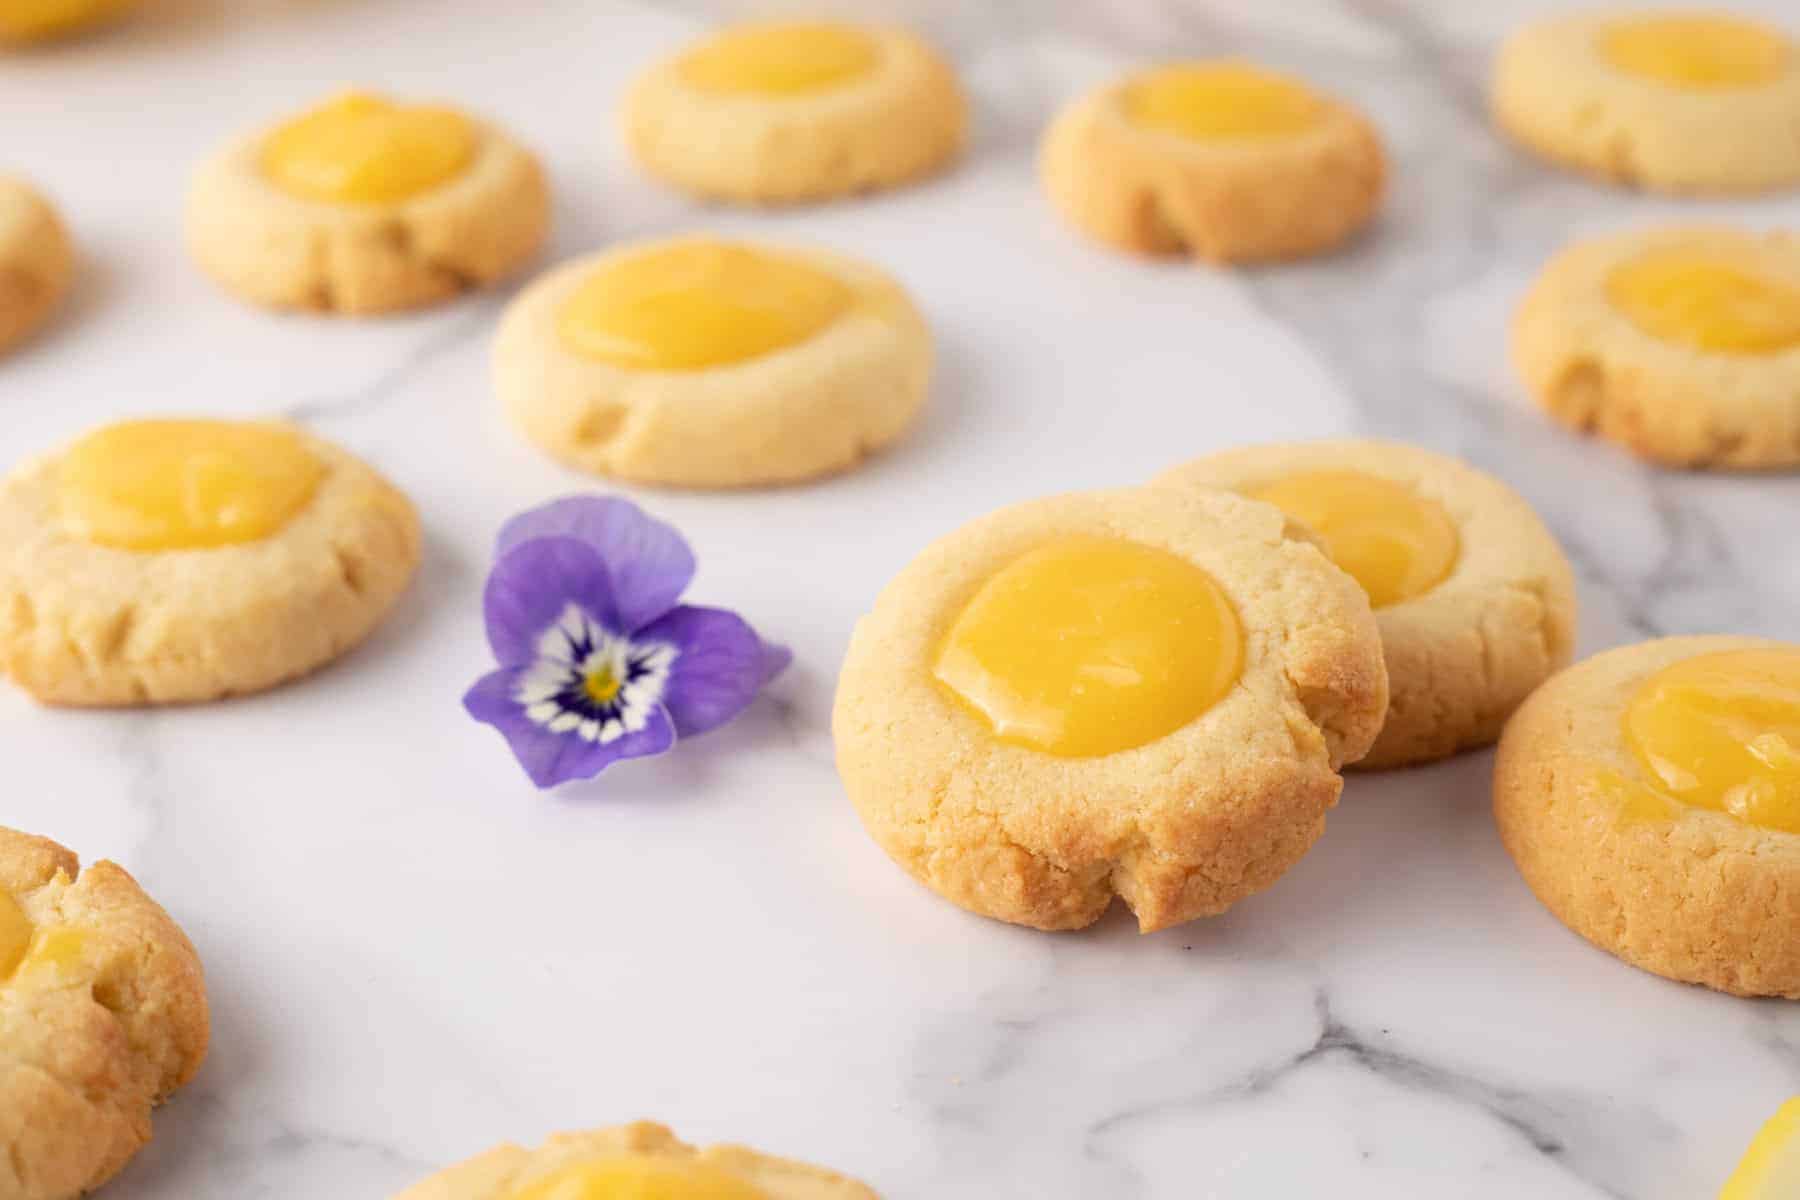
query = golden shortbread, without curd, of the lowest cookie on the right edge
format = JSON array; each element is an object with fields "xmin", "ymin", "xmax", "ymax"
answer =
[{"xmin": 1494, "ymin": 637, "xmax": 1800, "ymax": 999}]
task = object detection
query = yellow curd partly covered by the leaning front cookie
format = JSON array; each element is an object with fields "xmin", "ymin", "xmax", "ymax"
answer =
[{"xmin": 1246, "ymin": 471, "xmax": 1462, "ymax": 608}]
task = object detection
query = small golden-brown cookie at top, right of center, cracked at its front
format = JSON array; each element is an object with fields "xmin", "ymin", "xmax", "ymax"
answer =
[{"xmin": 1039, "ymin": 61, "xmax": 1388, "ymax": 263}]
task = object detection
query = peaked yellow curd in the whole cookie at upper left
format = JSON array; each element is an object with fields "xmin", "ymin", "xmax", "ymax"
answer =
[{"xmin": 263, "ymin": 92, "xmax": 475, "ymax": 203}]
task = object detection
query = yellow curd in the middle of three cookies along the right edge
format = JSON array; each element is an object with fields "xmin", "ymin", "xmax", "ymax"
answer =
[{"xmin": 1606, "ymin": 250, "xmax": 1800, "ymax": 354}]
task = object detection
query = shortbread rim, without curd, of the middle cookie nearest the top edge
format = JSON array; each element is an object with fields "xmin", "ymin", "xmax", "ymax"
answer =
[{"xmin": 623, "ymin": 29, "xmax": 968, "ymax": 205}]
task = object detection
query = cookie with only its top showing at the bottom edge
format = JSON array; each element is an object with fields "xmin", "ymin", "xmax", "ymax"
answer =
[{"xmin": 394, "ymin": 1121, "xmax": 878, "ymax": 1200}]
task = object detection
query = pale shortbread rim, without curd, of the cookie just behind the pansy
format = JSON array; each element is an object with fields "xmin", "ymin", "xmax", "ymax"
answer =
[{"xmin": 493, "ymin": 245, "xmax": 932, "ymax": 488}]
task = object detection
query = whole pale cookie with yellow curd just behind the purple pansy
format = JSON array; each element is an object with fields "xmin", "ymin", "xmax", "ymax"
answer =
[{"xmin": 493, "ymin": 237, "xmax": 932, "ymax": 488}]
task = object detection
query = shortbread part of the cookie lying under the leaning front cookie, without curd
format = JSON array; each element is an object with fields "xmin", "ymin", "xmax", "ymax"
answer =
[{"xmin": 1156, "ymin": 439, "xmax": 1575, "ymax": 770}]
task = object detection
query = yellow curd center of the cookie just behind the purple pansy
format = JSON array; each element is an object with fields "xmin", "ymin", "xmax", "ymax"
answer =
[{"xmin": 556, "ymin": 239, "xmax": 855, "ymax": 371}]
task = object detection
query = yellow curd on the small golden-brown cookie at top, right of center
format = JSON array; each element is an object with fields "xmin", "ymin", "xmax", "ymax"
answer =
[{"xmin": 1125, "ymin": 63, "xmax": 1321, "ymax": 142}]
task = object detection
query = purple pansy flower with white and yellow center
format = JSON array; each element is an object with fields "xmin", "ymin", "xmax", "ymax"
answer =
[{"xmin": 463, "ymin": 497, "xmax": 794, "ymax": 788}]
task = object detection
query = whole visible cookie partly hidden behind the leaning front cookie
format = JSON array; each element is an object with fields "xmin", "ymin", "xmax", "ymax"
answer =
[{"xmin": 1156, "ymin": 439, "xmax": 1575, "ymax": 768}]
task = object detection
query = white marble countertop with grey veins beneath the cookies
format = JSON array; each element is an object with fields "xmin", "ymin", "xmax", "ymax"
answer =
[{"xmin": 0, "ymin": 0, "xmax": 1800, "ymax": 1200}]
